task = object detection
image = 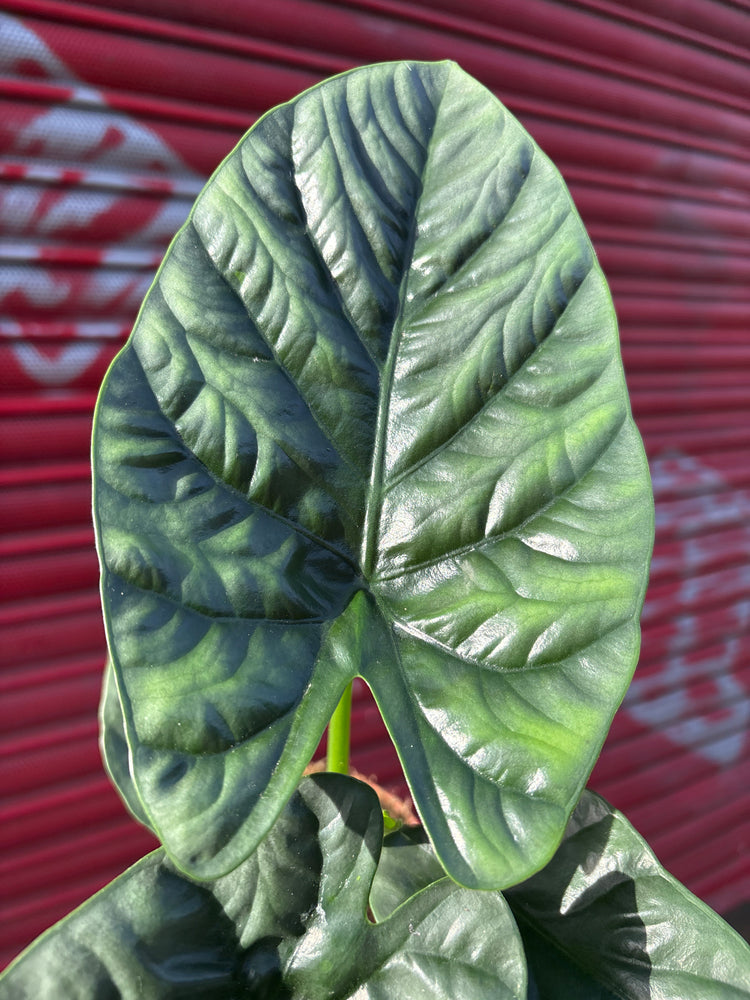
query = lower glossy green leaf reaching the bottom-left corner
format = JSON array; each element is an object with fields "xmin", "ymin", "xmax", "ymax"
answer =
[{"xmin": 0, "ymin": 774, "xmax": 526, "ymax": 1000}]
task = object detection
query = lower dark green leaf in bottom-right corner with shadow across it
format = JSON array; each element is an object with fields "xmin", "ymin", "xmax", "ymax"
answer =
[{"xmin": 505, "ymin": 792, "xmax": 750, "ymax": 1000}]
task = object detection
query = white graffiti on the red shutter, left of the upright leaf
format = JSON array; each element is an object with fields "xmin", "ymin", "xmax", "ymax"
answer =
[{"xmin": 0, "ymin": 14, "xmax": 202, "ymax": 387}]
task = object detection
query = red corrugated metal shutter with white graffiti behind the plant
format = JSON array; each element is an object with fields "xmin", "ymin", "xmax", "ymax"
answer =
[{"xmin": 0, "ymin": 0, "xmax": 750, "ymax": 961}]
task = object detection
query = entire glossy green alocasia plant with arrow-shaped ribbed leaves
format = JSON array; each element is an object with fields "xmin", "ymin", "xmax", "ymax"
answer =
[{"xmin": 2, "ymin": 63, "xmax": 750, "ymax": 1000}]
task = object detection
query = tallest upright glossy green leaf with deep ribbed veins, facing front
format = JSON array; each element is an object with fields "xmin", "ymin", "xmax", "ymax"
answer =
[{"xmin": 93, "ymin": 63, "xmax": 653, "ymax": 887}]
